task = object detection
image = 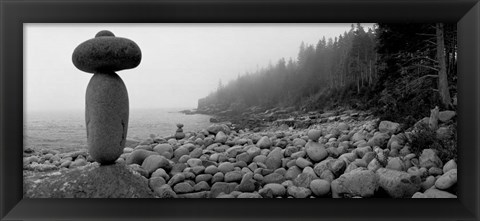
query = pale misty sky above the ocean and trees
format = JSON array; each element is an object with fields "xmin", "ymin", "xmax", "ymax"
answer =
[{"xmin": 24, "ymin": 24, "xmax": 371, "ymax": 111}]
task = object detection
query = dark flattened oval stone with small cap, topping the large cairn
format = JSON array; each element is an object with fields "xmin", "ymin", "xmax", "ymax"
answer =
[{"xmin": 72, "ymin": 30, "xmax": 142, "ymax": 73}]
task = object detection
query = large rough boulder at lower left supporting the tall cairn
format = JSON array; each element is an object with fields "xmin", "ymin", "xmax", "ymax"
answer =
[{"xmin": 24, "ymin": 163, "xmax": 155, "ymax": 198}]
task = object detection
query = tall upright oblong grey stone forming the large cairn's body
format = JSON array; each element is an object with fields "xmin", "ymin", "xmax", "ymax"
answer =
[{"xmin": 85, "ymin": 72, "xmax": 129, "ymax": 164}]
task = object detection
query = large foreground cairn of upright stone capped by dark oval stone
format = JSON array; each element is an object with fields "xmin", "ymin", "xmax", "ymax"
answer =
[{"xmin": 72, "ymin": 30, "xmax": 142, "ymax": 165}]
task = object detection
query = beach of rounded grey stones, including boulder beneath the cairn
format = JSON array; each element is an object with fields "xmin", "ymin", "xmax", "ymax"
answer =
[{"xmin": 23, "ymin": 108, "xmax": 457, "ymax": 198}]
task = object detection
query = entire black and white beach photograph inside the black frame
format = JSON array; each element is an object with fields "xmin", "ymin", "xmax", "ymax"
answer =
[{"xmin": 19, "ymin": 21, "xmax": 459, "ymax": 200}]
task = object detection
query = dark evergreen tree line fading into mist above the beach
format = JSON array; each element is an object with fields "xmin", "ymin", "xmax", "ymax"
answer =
[{"xmin": 198, "ymin": 23, "xmax": 457, "ymax": 127}]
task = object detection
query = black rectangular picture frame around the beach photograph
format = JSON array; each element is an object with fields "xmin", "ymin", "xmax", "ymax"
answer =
[{"xmin": 0, "ymin": 0, "xmax": 480, "ymax": 220}]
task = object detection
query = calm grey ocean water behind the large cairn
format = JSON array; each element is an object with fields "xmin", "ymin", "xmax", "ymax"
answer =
[{"xmin": 24, "ymin": 108, "xmax": 211, "ymax": 152}]
